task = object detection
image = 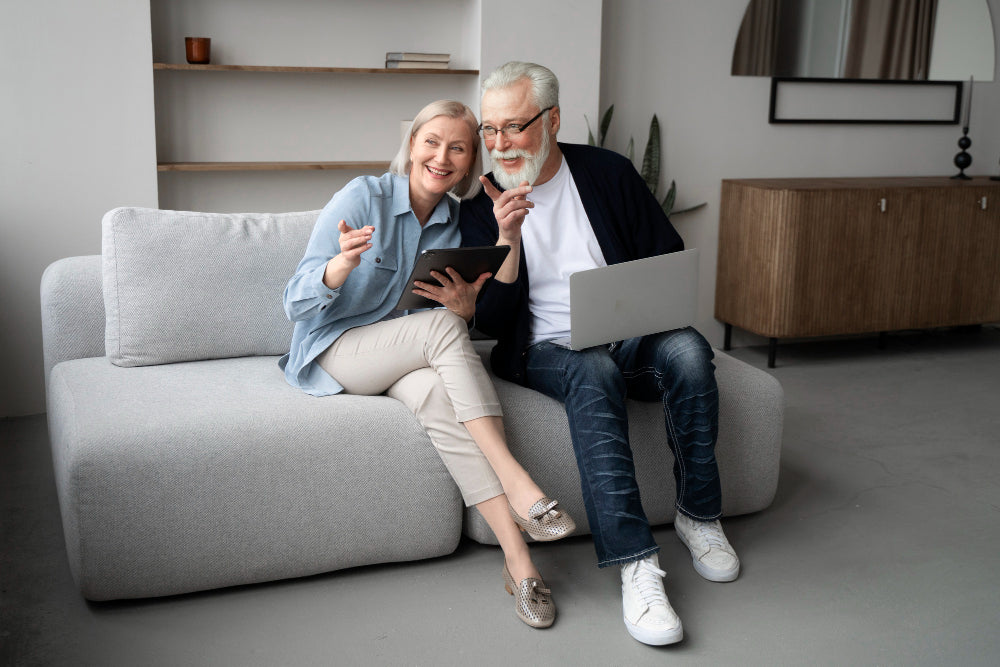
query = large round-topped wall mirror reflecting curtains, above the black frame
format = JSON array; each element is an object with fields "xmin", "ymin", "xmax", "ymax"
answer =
[{"xmin": 732, "ymin": 0, "xmax": 995, "ymax": 81}]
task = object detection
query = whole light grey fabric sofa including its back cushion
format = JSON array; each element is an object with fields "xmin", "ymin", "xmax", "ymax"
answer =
[{"xmin": 41, "ymin": 208, "xmax": 783, "ymax": 600}]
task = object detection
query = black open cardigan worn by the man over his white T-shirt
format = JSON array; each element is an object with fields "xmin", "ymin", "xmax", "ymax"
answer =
[{"xmin": 459, "ymin": 143, "xmax": 684, "ymax": 384}]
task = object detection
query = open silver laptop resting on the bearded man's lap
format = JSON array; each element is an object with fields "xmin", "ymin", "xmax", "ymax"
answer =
[{"xmin": 569, "ymin": 248, "xmax": 698, "ymax": 350}]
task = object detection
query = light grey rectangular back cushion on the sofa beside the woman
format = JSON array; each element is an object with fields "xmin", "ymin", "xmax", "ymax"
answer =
[{"xmin": 102, "ymin": 208, "xmax": 319, "ymax": 366}]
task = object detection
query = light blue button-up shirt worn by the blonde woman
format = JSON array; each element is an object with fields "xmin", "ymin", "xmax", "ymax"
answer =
[{"xmin": 278, "ymin": 173, "xmax": 461, "ymax": 396}]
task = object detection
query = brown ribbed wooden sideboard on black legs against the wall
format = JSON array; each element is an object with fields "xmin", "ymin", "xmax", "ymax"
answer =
[{"xmin": 715, "ymin": 177, "xmax": 1000, "ymax": 368}]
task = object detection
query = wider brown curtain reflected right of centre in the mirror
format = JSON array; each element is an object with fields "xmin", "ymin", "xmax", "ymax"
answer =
[{"xmin": 844, "ymin": 0, "xmax": 937, "ymax": 81}]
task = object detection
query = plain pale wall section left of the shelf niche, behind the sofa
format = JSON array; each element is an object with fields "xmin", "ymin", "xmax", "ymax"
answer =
[{"xmin": 0, "ymin": 0, "xmax": 157, "ymax": 416}]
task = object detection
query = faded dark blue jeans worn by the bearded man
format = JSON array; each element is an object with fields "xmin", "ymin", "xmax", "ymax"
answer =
[{"xmin": 526, "ymin": 328, "xmax": 722, "ymax": 567}]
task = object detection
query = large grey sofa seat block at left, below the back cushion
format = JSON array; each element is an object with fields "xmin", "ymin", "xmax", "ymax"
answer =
[{"xmin": 48, "ymin": 357, "xmax": 462, "ymax": 600}]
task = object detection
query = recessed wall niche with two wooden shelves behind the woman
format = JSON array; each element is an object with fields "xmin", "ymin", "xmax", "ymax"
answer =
[{"xmin": 148, "ymin": 0, "xmax": 482, "ymax": 211}]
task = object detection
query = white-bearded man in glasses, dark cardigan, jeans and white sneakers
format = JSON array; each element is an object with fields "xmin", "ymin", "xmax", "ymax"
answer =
[{"xmin": 460, "ymin": 62, "xmax": 740, "ymax": 645}]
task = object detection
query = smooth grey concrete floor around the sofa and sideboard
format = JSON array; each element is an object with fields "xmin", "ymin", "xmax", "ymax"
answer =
[{"xmin": 0, "ymin": 327, "xmax": 1000, "ymax": 666}]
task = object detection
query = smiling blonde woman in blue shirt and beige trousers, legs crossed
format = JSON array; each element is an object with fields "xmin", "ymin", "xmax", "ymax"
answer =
[{"xmin": 281, "ymin": 100, "xmax": 575, "ymax": 627}]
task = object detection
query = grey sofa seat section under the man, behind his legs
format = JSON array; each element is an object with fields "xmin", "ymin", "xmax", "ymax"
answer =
[{"xmin": 465, "ymin": 348, "xmax": 784, "ymax": 544}]
